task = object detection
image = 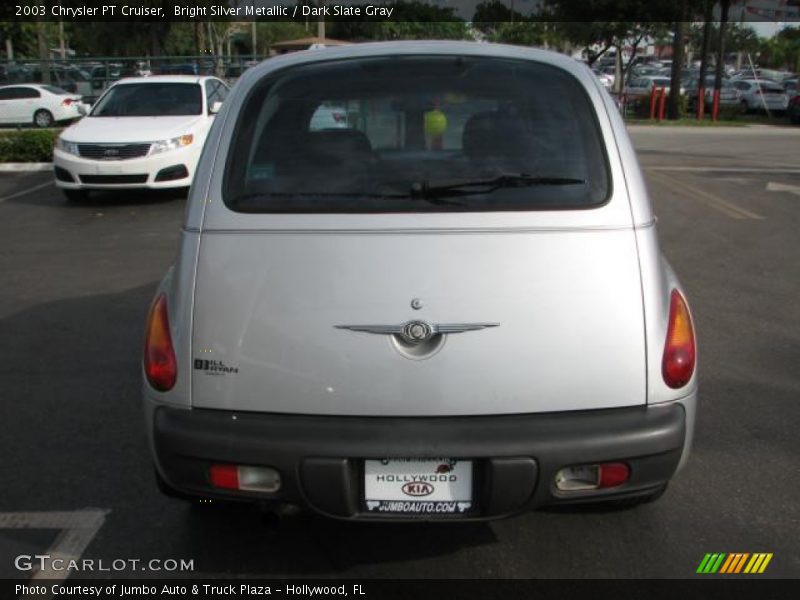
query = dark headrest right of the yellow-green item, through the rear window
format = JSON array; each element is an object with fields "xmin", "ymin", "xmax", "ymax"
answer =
[{"xmin": 462, "ymin": 112, "xmax": 534, "ymax": 161}]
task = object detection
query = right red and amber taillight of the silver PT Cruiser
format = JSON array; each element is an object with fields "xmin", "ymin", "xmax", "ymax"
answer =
[{"xmin": 661, "ymin": 290, "xmax": 696, "ymax": 388}]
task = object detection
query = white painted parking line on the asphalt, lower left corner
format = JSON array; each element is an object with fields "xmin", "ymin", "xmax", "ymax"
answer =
[{"xmin": 0, "ymin": 508, "xmax": 110, "ymax": 581}]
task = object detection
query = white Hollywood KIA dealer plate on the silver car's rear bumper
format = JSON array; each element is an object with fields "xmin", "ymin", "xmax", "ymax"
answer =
[{"xmin": 364, "ymin": 458, "xmax": 473, "ymax": 514}]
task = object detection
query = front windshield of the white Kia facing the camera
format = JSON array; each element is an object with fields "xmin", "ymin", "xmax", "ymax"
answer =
[{"xmin": 90, "ymin": 82, "xmax": 203, "ymax": 117}]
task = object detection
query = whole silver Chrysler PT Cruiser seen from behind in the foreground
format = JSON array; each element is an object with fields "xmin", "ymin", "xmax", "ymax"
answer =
[{"xmin": 143, "ymin": 42, "xmax": 697, "ymax": 519}]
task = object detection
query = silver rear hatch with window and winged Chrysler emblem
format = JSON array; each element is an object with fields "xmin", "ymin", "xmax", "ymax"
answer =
[{"xmin": 192, "ymin": 52, "xmax": 646, "ymax": 416}]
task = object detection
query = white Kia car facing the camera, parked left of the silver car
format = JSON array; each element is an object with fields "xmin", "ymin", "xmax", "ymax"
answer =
[{"xmin": 53, "ymin": 76, "xmax": 228, "ymax": 200}]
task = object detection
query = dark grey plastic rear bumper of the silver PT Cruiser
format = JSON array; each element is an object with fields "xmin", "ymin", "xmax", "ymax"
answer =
[{"xmin": 148, "ymin": 402, "xmax": 688, "ymax": 520}]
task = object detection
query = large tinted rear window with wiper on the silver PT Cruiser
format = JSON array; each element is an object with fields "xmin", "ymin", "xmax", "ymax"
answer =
[{"xmin": 224, "ymin": 56, "xmax": 610, "ymax": 213}]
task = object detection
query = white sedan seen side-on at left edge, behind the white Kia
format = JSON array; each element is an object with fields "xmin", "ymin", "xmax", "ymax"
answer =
[{"xmin": 0, "ymin": 84, "xmax": 85, "ymax": 127}]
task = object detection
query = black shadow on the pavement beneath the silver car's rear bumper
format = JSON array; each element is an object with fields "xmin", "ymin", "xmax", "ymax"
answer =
[{"xmin": 179, "ymin": 505, "xmax": 497, "ymax": 577}]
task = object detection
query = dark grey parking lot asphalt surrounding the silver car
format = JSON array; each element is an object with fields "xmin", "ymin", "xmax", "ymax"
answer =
[{"xmin": 0, "ymin": 127, "xmax": 800, "ymax": 578}]
